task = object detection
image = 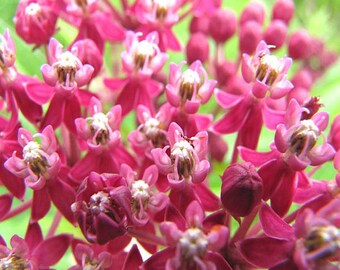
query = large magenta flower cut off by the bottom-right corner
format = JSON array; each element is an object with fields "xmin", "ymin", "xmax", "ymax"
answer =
[{"xmin": 239, "ymin": 199, "xmax": 340, "ymax": 270}]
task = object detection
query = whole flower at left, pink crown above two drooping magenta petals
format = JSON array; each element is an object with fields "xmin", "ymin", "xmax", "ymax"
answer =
[{"xmin": 4, "ymin": 126, "xmax": 75, "ymax": 223}]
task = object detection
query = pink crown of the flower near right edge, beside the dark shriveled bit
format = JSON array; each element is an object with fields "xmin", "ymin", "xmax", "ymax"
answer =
[{"xmin": 275, "ymin": 99, "xmax": 335, "ymax": 170}]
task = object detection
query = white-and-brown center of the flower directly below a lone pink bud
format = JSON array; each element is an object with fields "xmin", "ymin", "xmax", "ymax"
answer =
[{"xmin": 179, "ymin": 69, "xmax": 201, "ymax": 102}]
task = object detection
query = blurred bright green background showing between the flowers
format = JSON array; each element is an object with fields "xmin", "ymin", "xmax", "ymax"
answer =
[{"xmin": 0, "ymin": 0, "xmax": 340, "ymax": 269}]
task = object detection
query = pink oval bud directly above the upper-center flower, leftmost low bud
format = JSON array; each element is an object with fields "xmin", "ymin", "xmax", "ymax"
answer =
[{"xmin": 186, "ymin": 32, "xmax": 209, "ymax": 65}]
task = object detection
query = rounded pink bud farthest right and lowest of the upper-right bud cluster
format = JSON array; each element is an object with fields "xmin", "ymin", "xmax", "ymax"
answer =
[{"xmin": 288, "ymin": 30, "xmax": 312, "ymax": 59}]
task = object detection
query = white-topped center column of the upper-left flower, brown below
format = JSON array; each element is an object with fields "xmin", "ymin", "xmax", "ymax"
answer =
[{"xmin": 53, "ymin": 51, "xmax": 81, "ymax": 87}]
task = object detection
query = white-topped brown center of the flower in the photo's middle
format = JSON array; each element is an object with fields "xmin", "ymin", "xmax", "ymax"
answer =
[{"xmin": 171, "ymin": 139, "xmax": 195, "ymax": 178}]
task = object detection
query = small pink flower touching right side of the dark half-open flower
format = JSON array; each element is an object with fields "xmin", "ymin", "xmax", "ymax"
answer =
[{"xmin": 120, "ymin": 164, "xmax": 169, "ymax": 226}]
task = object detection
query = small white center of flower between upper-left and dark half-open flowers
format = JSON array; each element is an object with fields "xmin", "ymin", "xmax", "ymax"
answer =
[{"xmin": 89, "ymin": 112, "xmax": 110, "ymax": 145}]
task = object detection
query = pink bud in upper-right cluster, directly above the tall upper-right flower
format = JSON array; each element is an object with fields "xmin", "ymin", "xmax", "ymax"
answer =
[{"xmin": 240, "ymin": 21, "xmax": 262, "ymax": 54}]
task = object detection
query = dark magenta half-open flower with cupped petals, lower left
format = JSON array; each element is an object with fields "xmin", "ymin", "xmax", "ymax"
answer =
[{"xmin": 71, "ymin": 172, "xmax": 131, "ymax": 245}]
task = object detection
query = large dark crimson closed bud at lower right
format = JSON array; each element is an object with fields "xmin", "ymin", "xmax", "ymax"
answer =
[{"xmin": 221, "ymin": 162, "xmax": 263, "ymax": 217}]
